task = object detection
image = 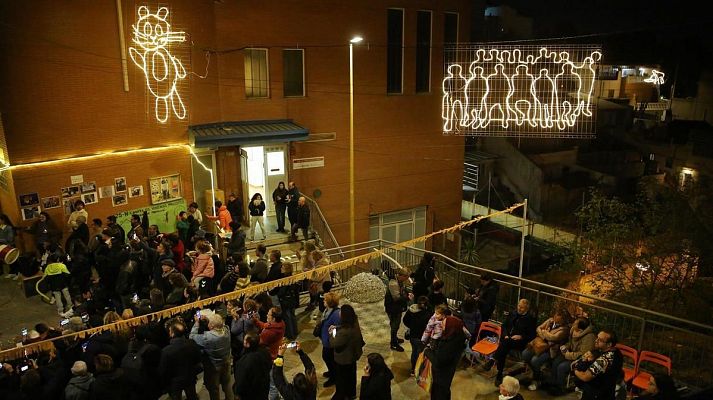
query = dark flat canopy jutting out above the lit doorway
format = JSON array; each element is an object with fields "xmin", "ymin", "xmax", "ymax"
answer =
[{"xmin": 188, "ymin": 119, "xmax": 309, "ymax": 147}]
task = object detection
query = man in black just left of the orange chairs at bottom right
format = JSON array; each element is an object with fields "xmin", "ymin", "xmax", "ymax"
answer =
[{"xmin": 574, "ymin": 330, "xmax": 624, "ymax": 400}]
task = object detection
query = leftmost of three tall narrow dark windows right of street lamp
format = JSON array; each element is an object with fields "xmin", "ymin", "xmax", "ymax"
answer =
[{"xmin": 386, "ymin": 9, "xmax": 404, "ymax": 93}]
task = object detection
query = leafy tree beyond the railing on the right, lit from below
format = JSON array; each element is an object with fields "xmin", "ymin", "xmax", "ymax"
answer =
[{"xmin": 571, "ymin": 185, "xmax": 701, "ymax": 311}]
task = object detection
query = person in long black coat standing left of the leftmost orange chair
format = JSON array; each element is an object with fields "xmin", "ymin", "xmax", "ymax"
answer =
[{"xmin": 425, "ymin": 317, "xmax": 467, "ymax": 400}]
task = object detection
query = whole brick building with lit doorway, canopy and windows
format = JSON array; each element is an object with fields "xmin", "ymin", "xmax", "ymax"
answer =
[{"xmin": 0, "ymin": 0, "xmax": 483, "ymax": 250}]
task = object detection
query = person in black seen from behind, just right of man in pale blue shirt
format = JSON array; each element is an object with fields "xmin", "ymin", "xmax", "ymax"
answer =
[{"xmin": 234, "ymin": 332, "xmax": 272, "ymax": 400}]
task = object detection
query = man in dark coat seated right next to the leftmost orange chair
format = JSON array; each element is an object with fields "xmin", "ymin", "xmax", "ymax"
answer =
[{"xmin": 484, "ymin": 299, "xmax": 537, "ymax": 385}]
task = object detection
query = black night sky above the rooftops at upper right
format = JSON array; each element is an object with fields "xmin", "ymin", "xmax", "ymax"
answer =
[{"xmin": 487, "ymin": 0, "xmax": 713, "ymax": 97}]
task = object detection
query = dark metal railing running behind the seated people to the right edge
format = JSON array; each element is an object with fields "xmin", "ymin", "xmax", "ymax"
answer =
[{"xmin": 320, "ymin": 240, "xmax": 713, "ymax": 386}]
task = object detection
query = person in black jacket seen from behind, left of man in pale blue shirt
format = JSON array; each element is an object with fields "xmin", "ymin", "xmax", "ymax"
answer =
[{"xmin": 158, "ymin": 320, "xmax": 201, "ymax": 400}]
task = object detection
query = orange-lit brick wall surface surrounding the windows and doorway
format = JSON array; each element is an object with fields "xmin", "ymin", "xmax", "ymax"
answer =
[{"xmin": 0, "ymin": 0, "xmax": 478, "ymax": 243}]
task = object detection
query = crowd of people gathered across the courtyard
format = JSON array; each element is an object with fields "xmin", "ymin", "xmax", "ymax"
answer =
[{"xmin": 0, "ymin": 198, "xmax": 675, "ymax": 400}]
